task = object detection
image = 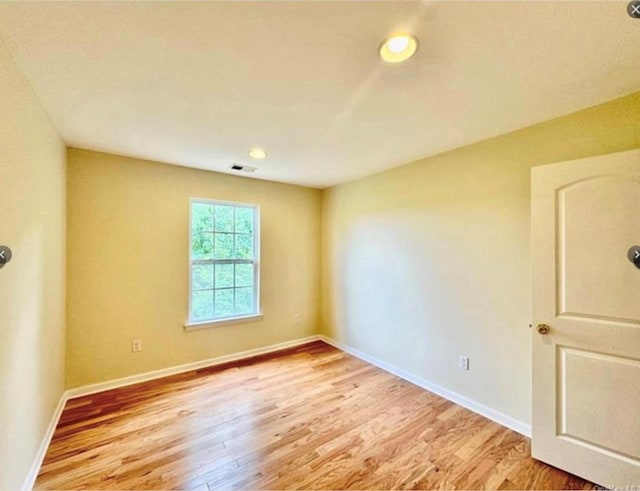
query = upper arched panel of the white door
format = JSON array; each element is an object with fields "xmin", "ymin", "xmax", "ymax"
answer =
[{"xmin": 556, "ymin": 176, "xmax": 640, "ymax": 323}]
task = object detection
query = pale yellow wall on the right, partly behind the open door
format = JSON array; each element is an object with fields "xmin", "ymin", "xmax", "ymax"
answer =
[{"xmin": 321, "ymin": 93, "xmax": 640, "ymax": 424}]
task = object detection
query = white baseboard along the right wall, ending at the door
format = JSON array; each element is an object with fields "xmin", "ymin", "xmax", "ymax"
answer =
[{"xmin": 319, "ymin": 335, "xmax": 531, "ymax": 438}]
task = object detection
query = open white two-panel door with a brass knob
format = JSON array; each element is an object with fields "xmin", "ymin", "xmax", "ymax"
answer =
[{"xmin": 531, "ymin": 150, "xmax": 640, "ymax": 489}]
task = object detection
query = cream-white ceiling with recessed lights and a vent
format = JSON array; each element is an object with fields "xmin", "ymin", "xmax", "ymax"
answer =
[{"xmin": 0, "ymin": 0, "xmax": 640, "ymax": 187}]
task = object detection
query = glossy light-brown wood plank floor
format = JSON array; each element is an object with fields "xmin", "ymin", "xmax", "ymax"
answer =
[{"xmin": 36, "ymin": 342, "xmax": 593, "ymax": 491}]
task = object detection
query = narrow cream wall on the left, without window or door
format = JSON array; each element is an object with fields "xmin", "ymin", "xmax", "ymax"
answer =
[{"xmin": 0, "ymin": 40, "xmax": 65, "ymax": 489}]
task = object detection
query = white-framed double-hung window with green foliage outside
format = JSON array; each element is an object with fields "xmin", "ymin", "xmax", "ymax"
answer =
[{"xmin": 187, "ymin": 199, "xmax": 260, "ymax": 327}]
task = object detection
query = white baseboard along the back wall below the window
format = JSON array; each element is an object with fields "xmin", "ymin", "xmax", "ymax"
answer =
[{"xmin": 65, "ymin": 336, "xmax": 320, "ymax": 399}]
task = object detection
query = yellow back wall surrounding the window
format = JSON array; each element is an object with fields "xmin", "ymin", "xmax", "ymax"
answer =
[{"xmin": 67, "ymin": 149, "xmax": 321, "ymax": 387}]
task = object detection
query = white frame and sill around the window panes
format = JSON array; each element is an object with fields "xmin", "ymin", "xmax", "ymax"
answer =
[{"xmin": 184, "ymin": 198, "xmax": 262, "ymax": 330}]
